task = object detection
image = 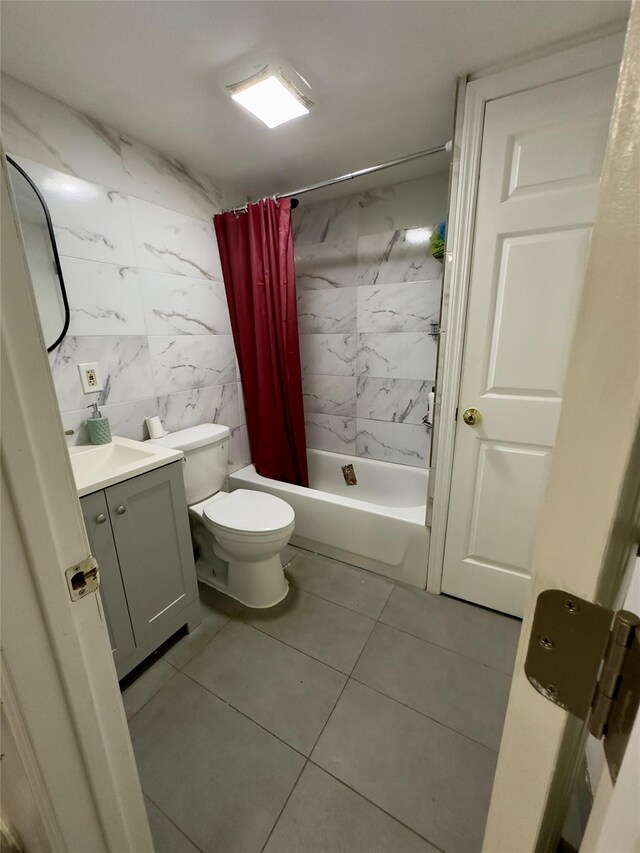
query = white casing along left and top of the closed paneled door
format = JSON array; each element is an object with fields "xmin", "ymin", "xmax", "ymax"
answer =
[{"xmin": 427, "ymin": 30, "xmax": 624, "ymax": 595}]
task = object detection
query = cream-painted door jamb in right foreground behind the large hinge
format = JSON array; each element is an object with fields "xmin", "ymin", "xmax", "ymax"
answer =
[{"xmin": 483, "ymin": 3, "xmax": 640, "ymax": 853}]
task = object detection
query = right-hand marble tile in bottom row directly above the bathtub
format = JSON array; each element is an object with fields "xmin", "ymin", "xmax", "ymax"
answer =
[{"xmin": 356, "ymin": 418, "xmax": 429, "ymax": 468}]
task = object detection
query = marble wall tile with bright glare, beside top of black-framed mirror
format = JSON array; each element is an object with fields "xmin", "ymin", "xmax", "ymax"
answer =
[{"xmin": 15, "ymin": 157, "xmax": 136, "ymax": 266}]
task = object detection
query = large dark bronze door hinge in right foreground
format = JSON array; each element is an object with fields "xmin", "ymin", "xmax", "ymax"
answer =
[{"xmin": 524, "ymin": 589, "xmax": 640, "ymax": 782}]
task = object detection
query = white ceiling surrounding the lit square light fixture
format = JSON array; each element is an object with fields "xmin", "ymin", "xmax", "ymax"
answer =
[{"xmin": 1, "ymin": 0, "xmax": 629, "ymax": 196}]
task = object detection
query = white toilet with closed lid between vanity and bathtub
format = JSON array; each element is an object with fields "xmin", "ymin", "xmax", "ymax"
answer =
[{"xmin": 151, "ymin": 424, "xmax": 295, "ymax": 608}]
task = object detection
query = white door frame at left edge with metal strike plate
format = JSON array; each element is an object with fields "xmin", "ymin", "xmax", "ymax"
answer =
[{"xmin": 0, "ymin": 151, "xmax": 153, "ymax": 853}]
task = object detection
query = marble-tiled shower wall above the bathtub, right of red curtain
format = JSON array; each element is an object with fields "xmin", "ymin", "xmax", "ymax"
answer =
[{"xmin": 293, "ymin": 175, "xmax": 447, "ymax": 467}]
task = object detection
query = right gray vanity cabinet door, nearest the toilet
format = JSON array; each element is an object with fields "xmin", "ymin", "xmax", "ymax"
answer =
[{"xmin": 105, "ymin": 462, "xmax": 198, "ymax": 648}]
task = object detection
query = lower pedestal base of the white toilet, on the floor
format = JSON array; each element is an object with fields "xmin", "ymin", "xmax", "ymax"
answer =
[{"xmin": 196, "ymin": 554, "xmax": 289, "ymax": 610}]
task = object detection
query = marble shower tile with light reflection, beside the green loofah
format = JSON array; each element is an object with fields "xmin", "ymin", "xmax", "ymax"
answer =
[{"xmin": 358, "ymin": 230, "xmax": 442, "ymax": 286}]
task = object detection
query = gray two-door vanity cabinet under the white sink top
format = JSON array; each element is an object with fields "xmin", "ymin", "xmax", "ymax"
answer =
[{"xmin": 81, "ymin": 462, "xmax": 200, "ymax": 678}]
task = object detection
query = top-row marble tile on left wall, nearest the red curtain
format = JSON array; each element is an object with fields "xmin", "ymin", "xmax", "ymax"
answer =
[{"xmin": 120, "ymin": 134, "xmax": 223, "ymax": 220}]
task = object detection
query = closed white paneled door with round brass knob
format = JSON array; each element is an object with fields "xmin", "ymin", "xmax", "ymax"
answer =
[{"xmin": 442, "ymin": 67, "xmax": 618, "ymax": 616}]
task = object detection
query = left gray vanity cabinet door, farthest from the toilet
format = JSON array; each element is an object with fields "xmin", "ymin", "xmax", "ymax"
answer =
[{"xmin": 80, "ymin": 492, "xmax": 135, "ymax": 665}]
